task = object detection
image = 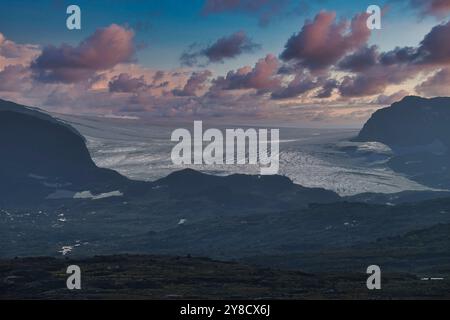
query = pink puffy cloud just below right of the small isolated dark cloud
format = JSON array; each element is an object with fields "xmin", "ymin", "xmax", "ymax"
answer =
[{"xmin": 213, "ymin": 54, "xmax": 281, "ymax": 93}]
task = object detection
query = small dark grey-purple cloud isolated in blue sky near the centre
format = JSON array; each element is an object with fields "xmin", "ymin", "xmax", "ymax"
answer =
[{"xmin": 180, "ymin": 31, "xmax": 260, "ymax": 66}]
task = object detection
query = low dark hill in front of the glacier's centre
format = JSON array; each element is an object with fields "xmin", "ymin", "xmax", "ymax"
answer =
[{"xmin": 154, "ymin": 169, "xmax": 340, "ymax": 210}]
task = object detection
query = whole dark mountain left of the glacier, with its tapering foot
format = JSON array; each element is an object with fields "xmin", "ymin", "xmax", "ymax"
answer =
[{"xmin": 0, "ymin": 100, "xmax": 127, "ymax": 202}]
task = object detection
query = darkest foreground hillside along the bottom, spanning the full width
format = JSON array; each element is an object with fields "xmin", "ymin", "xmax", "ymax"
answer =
[{"xmin": 0, "ymin": 255, "xmax": 450, "ymax": 299}]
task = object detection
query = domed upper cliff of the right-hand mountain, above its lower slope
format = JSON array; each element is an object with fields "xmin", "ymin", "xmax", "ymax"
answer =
[{"xmin": 355, "ymin": 96, "xmax": 450, "ymax": 147}]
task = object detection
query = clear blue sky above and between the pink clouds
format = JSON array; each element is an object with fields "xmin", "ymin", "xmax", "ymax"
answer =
[{"xmin": 0, "ymin": 0, "xmax": 435, "ymax": 73}]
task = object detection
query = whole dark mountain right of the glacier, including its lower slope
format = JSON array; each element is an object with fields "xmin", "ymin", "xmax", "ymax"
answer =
[{"xmin": 355, "ymin": 96, "xmax": 450, "ymax": 189}]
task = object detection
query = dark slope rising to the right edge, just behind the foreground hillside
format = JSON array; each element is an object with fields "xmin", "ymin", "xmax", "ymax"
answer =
[{"xmin": 243, "ymin": 224, "xmax": 450, "ymax": 274}]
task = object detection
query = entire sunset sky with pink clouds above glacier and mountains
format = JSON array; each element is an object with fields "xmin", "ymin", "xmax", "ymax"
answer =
[{"xmin": 0, "ymin": 0, "xmax": 450, "ymax": 127}]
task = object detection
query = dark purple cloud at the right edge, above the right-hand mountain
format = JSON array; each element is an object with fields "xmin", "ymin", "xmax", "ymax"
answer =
[{"xmin": 338, "ymin": 22, "xmax": 450, "ymax": 97}]
